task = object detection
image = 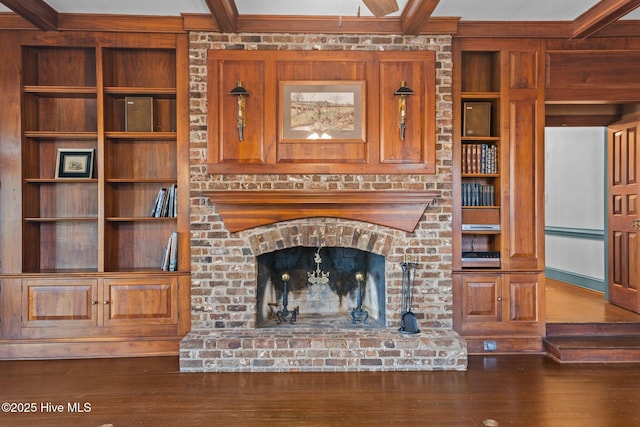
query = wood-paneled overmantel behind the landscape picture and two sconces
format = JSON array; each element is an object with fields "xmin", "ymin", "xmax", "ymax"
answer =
[{"xmin": 207, "ymin": 49, "xmax": 436, "ymax": 174}]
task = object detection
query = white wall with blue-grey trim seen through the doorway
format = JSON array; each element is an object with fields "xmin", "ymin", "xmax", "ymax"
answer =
[{"xmin": 545, "ymin": 127, "xmax": 607, "ymax": 292}]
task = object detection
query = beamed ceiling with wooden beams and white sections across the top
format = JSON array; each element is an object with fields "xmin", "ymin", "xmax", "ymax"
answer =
[{"xmin": 0, "ymin": 0, "xmax": 640, "ymax": 39}]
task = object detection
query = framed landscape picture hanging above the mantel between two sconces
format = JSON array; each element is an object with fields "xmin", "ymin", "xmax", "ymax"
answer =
[{"xmin": 279, "ymin": 80, "xmax": 366, "ymax": 142}]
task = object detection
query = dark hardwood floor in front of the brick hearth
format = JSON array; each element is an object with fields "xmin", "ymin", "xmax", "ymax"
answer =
[{"xmin": 0, "ymin": 355, "xmax": 640, "ymax": 427}]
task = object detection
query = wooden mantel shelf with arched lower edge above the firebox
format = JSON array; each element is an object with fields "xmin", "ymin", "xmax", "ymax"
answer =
[{"xmin": 202, "ymin": 190, "xmax": 440, "ymax": 232}]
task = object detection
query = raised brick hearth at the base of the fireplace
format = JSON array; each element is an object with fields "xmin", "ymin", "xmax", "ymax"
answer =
[{"xmin": 180, "ymin": 328, "xmax": 467, "ymax": 372}]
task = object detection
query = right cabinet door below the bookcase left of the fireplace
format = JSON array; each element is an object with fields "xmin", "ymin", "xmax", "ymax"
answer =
[{"xmin": 103, "ymin": 277, "xmax": 178, "ymax": 326}]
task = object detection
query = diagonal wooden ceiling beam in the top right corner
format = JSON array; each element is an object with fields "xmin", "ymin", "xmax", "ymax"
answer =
[{"xmin": 573, "ymin": 0, "xmax": 640, "ymax": 38}]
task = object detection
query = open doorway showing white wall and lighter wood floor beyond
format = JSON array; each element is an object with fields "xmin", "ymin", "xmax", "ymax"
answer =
[{"xmin": 545, "ymin": 126, "xmax": 640, "ymax": 323}]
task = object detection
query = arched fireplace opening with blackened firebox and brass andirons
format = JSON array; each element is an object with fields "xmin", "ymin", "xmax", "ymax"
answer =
[{"xmin": 256, "ymin": 246, "xmax": 386, "ymax": 328}]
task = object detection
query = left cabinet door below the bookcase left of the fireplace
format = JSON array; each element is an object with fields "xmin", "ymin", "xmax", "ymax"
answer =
[{"xmin": 22, "ymin": 279, "xmax": 97, "ymax": 327}]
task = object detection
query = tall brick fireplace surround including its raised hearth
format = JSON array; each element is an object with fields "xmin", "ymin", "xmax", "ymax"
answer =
[{"xmin": 180, "ymin": 32, "xmax": 467, "ymax": 372}]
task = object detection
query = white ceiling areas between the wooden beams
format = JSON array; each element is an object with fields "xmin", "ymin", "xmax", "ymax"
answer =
[{"xmin": 0, "ymin": 0, "xmax": 640, "ymax": 21}]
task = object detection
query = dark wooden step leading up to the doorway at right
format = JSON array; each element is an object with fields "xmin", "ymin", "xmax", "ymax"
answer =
[{"xmin": 544, "ymin": 323, "xmax": 640, "ymax": 363}]
